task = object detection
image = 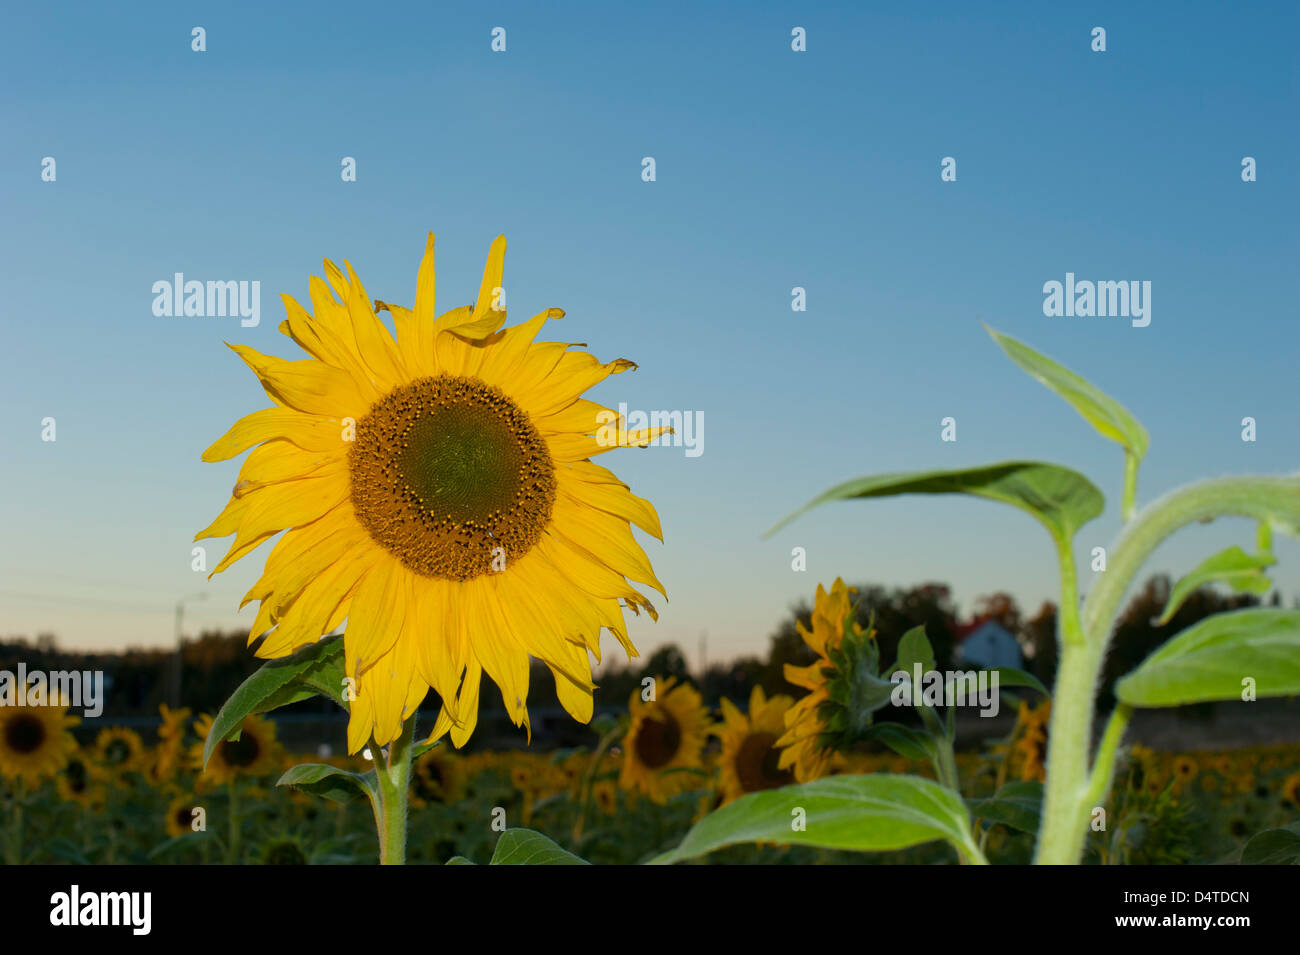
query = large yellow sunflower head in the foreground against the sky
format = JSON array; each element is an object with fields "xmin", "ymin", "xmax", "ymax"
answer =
[{"xmin": 204, "ymin": 234, "xmax": 668, "ymax": 752}]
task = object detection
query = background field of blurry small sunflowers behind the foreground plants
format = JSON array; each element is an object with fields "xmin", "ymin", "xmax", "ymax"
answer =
[{"xmin": 0, "ymin": 685, "xmax": 1300, "ymax": 865}]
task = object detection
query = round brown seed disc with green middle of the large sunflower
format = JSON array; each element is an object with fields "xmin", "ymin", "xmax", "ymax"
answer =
[{"xmin": 348, "ymin": 376, "xmax": 555, "ymax": 581}]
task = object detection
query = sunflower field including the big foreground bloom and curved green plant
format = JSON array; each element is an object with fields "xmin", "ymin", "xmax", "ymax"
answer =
[{"xmin": 0, "ymin": 234, "xmax": 1300, "ymax": 864}]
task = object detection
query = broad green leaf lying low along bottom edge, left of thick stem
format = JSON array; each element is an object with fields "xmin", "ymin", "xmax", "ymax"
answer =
[{"xmin": 651, "ymin": 773, "xmax": 984, "ymax": 864}]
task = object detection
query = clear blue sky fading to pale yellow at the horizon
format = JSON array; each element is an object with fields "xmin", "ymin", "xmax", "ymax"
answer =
[{"xmin": 0, "ymin": 3, "xmax": 1300, "ymax": 659}]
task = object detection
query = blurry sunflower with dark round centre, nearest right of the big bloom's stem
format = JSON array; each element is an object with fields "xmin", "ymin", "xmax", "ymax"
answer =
[{"xmin": 619, "ymin": 677, "xmax": 712, "ymax": 803}]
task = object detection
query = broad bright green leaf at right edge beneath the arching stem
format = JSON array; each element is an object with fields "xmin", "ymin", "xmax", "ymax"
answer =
[{"xmin": 1115, "ymin": 608, "xmax": 1300, "ymax": 707}]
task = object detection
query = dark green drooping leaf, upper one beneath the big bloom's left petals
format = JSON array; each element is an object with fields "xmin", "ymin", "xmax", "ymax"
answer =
[{"xmin": 203, "ymin": 634, "xmax": 347, "ymax": 767}]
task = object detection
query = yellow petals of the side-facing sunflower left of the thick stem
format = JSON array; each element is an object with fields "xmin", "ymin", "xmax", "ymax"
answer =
[{"xmin": 776, "ymin": 577, "xmax": 875, "ymax": 782}]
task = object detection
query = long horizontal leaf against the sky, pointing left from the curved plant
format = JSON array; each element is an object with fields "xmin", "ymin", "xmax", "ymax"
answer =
[{"xmin": 767, "ymin": 461, "xmax": 1105, "ymax": 546}]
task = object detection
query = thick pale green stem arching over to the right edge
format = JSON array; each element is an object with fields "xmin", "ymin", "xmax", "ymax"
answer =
[{"xmin": 1035, "ymin": 477, "xmax": 1300, "ymax": 865}]
